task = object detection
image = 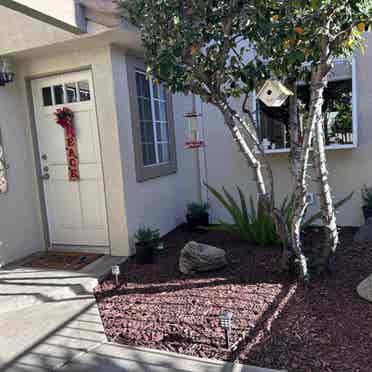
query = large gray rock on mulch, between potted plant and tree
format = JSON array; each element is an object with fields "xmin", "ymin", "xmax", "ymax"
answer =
[{"xmin": 179, "ymin": 241, "xmax": 227, "ymax": 274}]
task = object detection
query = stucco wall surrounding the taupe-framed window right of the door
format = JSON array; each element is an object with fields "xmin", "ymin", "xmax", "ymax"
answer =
[{"xmin": 112, "ymin": 48, "xmax": 197, "ymax": 247}]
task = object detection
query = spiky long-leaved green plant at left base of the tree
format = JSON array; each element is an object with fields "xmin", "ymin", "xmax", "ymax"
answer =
[{"xmin": 205, "ymin": 184, "xmax": 279, "ymax": 246}]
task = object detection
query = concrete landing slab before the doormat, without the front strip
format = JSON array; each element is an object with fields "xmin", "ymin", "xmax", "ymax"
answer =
[{"xmin": 0, "ymin": 256, "xmax": 123, "ymax": 372}]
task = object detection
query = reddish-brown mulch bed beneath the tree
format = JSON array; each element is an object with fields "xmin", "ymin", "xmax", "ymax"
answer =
[{"xmin": 96, "ymin": 228, "xmax": 372, "ymax": 372}]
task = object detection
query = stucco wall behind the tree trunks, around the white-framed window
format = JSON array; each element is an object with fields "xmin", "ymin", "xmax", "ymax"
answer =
[{"xmin": 203, "ymin": 33, "xmax": 372, "ymax": 226}]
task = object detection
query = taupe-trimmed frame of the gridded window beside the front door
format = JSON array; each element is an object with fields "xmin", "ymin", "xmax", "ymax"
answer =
[{"xmin": 126, "ymin": 56, "xmax": 177, "ymax": 182}]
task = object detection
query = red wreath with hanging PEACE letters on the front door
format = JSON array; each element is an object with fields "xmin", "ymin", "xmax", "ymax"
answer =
[{"xmin": 54, "ymin": 107, "xmax": 80, "ymax": 181}]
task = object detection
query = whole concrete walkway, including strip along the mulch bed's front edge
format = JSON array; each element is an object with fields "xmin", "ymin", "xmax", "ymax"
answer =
[{"xmin": 0, "ymin": 258, "xmax": 284, "ymax": 372}]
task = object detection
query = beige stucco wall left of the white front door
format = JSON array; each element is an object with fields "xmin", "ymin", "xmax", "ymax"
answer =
[{"xmin": 0, "ymin": 81, "xmax": 44, "ymax": 267}]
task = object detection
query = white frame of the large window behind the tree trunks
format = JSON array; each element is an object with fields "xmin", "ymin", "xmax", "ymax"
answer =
[{"xmin": 252, "ymin": 56, "xmax": 359, "ymax": 154}]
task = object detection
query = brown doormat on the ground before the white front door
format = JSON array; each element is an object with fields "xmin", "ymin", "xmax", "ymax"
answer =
[{"xmin": 22, "ymin": 252, "xmax": 103, "ymax": 271}]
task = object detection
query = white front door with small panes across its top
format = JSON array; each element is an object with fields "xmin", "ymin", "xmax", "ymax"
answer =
[{"xmin": 31, "ymin": 71, "xmax": 109, "ymax": 246}]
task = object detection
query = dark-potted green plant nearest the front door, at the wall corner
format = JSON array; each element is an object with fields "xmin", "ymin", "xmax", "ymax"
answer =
[{"xmin": 134, "ymin": 226, "xmax": 160, "ymax": 264}]
